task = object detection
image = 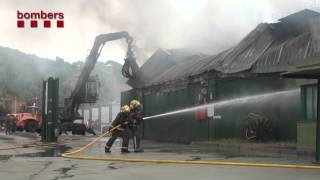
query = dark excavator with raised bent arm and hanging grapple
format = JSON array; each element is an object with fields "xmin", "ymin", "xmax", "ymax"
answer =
[{"xmin": 58, "ymin": 31, "xmax": 139, "ymax": 134}]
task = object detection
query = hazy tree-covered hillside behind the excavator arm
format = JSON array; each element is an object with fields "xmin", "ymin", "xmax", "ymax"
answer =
[{"xmin": 0, "ymin": 47, "xmax": 129, "ymax": 105}]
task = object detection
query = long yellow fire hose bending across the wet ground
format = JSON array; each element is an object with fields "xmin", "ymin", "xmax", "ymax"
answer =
[{"xmin": 62, "ymin": 125, "xmax": 320, "ymax": 170}]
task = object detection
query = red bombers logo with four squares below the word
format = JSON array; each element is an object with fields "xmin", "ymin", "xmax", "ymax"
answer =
[{"xmin": 17, "ymin": 11, "xmax": 64, "ymax": 28}]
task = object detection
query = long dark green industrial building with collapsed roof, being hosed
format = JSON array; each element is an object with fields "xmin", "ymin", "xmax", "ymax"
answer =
[{"xmin": 121, "ymin": 10, "xmax": 320, "ymax": 145}]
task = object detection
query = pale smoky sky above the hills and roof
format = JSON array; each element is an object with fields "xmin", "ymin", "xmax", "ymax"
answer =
[{"xmin": 0, "ymin": 0, "xmax": 320, "ymax": 65}]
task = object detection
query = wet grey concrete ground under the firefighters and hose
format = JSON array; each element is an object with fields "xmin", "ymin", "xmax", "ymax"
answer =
[{"xmin": 0, "ymin": 133, "xmax": 320, "ymax": 180}]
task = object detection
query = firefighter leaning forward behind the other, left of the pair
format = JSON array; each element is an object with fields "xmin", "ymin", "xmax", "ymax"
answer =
[{"xmin": 105, "ymin": 105, "xmax": 130, "ymax": 153}]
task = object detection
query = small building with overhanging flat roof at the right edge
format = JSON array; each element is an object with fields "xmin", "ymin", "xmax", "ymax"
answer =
[{"xmin": 282, "ymin": 58, "xmax": 320, "ymax": 162}]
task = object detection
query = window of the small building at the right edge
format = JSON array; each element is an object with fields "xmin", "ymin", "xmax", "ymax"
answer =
[{"xmin": 302, "ymin": 85, "xmax": 318, "ymax": 122}]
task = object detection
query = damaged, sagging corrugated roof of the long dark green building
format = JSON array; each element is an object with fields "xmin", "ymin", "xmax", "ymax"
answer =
[{"xmin": 132, "ymin": 10, "xmax": 320, "ymax": 86}]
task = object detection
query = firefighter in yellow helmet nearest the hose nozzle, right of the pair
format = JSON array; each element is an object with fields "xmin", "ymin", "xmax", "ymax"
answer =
[{"xmin": 129, "ymin": 100, "xmax": 143, "ymax": 152}]
